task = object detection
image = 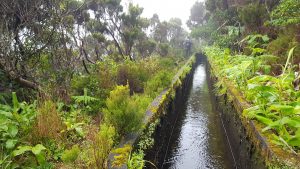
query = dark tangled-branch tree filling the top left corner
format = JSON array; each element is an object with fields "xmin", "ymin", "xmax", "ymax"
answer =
[{"xmin": 0, "ymin": 0, "xmax": 58, "ymax": 89}]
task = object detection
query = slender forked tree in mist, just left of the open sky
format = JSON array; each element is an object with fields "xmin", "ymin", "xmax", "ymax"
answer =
[{"xmin": 87, "ymin": 0, "xmax": 148, "ymax": 59}]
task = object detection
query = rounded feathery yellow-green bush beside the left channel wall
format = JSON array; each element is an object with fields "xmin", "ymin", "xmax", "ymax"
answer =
[{"xmin": 103, "ymin": 85, "xmax": 143, "ymax": 135}]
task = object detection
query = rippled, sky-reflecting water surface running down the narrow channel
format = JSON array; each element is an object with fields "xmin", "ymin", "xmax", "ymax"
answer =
[{"xmin": 161, "ymin": 64, "xmax": 232, "ymax": 169}]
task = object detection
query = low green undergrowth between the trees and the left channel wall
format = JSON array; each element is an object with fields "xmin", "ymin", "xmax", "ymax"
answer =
[{"xmin": 0, "ymin": 57, "xmax": 184, "ymax": 168}]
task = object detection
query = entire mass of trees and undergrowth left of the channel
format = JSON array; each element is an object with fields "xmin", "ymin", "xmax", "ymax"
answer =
[{"xmin": 0, "ymin": 0, "xmax": 187, "ymax": 169}]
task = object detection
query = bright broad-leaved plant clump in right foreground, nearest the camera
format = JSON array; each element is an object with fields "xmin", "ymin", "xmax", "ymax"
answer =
[{"xmin": 244, "ymin": 73, "xmax": 300, "ymax": 149}]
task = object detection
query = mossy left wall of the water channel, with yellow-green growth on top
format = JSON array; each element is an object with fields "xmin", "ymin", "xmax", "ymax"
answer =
[{"xmin": 107, "ymin": 55, "xmax": 198, "ymax": 169}]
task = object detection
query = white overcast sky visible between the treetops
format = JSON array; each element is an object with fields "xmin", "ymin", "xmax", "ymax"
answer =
[{"xmin": 122, "ymin": 0, "xmax": 203, "ymax": 28}]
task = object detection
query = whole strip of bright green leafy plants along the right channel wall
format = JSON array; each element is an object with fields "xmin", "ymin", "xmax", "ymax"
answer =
[{"xmin": 205, "ymin": 48, "xmax": 300, "ymax": 152}]
